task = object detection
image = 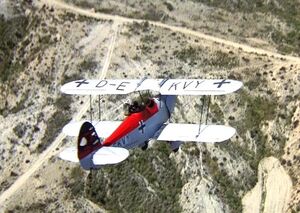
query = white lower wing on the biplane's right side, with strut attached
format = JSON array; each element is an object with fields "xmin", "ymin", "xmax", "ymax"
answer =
[{"xmin": 157, "ymin": 123, "xmax": 236, "ymax": 143}]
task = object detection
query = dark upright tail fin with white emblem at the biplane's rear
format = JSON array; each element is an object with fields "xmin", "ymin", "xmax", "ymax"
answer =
[{"xmin": 77, "ymin": 122, "xmax": 102, "ymax": 169}]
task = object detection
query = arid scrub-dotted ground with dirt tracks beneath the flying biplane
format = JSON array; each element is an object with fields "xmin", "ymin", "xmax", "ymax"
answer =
[{"xmin": 0, "ymin": 0, "xmax": 300, "ymax": 213}]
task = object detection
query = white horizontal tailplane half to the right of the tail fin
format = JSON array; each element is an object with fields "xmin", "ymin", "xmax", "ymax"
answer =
[{"xmin": 93, "ymin": 146, "xmax": 129, "ymax": 166}]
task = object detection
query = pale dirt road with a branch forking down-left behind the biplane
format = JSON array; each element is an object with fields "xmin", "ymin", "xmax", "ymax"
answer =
[{"xmin": 0, "ymin": 0, "xmax": 300, "ymax": 207}]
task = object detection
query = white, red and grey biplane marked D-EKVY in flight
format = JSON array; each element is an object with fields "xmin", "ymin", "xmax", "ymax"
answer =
[{"xmin": 59, "ymin": 78, "xmax": 243, "ymax": 170}]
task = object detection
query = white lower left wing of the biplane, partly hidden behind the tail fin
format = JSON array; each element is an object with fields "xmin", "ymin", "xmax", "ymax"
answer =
[{"xmin": 63, "ymin": 121, "xmax": 121, "ymax": 138}]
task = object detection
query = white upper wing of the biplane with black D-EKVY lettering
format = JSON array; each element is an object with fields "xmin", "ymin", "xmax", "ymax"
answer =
[{"xmin": 61, "ymin": 79, "xmax": 243, "ymax": 95}]
